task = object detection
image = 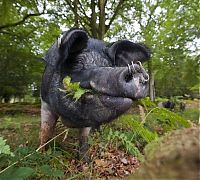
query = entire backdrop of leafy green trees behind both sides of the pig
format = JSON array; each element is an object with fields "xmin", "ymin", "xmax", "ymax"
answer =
[{"xmin": 0, "ymin": 0, "xmax": 200, "ymax": 101}]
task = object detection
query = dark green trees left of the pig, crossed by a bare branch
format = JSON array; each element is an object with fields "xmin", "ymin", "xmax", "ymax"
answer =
[{"xmin": 0, "ymin": 0, "xmax": 59, "ymax": 102}]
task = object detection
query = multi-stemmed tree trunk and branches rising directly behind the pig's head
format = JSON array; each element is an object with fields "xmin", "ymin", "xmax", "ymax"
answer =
[{"xmin": 64, "ymin": 0, "xmax": 133, "ymax": 40}]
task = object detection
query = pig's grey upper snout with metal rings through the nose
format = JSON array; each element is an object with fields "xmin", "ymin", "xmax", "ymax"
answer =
[{"xmin": 86, "ymin": 62, "xmax": 149, "ymax": 99}]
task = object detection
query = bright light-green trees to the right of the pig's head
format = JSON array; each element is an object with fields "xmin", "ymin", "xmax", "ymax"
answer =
[{"xmin": 112, "ymin": 0, "xmax": 199, "ymax": 100}]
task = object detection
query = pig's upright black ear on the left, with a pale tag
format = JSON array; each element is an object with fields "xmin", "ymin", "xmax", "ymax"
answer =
[{"xmin": 44, "ymin": 29, "xmax": 88, "ymax": 70}]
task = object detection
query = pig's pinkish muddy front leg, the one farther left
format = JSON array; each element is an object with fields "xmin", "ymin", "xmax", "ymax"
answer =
[{"xmin": 40, "ymin": 101, "xmax": 58, "ymax": 151}]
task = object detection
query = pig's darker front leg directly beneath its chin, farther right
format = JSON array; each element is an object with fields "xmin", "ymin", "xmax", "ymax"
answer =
[{"xmin": 78, "ymin": 127, "xmax": 91, "ymax": 163}]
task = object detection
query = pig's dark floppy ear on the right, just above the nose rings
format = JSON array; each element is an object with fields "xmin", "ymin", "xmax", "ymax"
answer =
[{"xmin": 108, "ymin": 40, "xmax": 151, "ymax": 66}]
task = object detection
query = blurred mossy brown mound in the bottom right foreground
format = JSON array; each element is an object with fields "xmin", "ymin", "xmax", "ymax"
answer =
[{"xmin": 130, "ymin": 127, "xmax": 200, "ymax": 180}]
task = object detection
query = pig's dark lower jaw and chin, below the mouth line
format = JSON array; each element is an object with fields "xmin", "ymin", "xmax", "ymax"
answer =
[{"xmin": 58, "ymin": 93, "xmax": 133, "ymax": 128}]
